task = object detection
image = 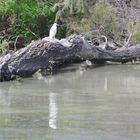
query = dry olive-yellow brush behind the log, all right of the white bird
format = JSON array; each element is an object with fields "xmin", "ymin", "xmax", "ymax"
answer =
[{"xmin": 54, "ymin": 0, "xmax": 140, "ymax": 43}]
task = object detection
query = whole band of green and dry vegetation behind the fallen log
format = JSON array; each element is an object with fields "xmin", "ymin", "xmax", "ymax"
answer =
[{"xmin": 0, "ymin": 0, "xmax": 140, "ymax": 53}]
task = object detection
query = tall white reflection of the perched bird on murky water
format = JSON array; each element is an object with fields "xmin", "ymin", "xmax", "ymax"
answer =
[{"xmin": 49, "ymin": 93, "xmax": 58, "ymax": 129}]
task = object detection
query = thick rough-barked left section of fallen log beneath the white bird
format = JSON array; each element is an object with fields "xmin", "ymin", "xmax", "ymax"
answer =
[{"xmin": 0, "ymin": 36, "xmax": 86, "ymax": 81}]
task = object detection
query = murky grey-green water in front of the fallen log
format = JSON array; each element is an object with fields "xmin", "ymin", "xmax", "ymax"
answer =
[{"xmin": 0, "ymin": 65, "xmax": 140, "ymax": 140}]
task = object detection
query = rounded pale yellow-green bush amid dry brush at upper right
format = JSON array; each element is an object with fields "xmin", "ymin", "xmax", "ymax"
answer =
[{"xmin": 90, "ymin": 2, "xmax": 120, "ymax": 38}]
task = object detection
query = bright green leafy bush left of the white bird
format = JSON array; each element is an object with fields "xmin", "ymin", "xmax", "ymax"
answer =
[{"xmin": 0, "ymin": 0, "xmax": 55, "ymax": 42}]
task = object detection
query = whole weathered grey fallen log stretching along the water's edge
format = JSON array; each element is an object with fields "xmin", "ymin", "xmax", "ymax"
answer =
[{"xmin": 0, "ymin": 35, "xmax": 140, "ymax": 81}]
